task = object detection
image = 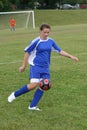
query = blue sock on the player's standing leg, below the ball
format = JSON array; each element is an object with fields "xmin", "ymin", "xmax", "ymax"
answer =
[{"xmin": 30, "ymin": 88, "xmax": 44, "ymax": 107}]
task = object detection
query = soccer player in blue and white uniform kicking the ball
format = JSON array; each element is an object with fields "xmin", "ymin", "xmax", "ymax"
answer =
[{"xmin": 8, "ymin": 24, "xmax": 78, "ymax": 110}]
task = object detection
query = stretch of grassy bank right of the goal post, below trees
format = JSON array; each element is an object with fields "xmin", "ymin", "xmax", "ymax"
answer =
[{"xmin": 35, "ymin": 10, "xmax": 87, "ymax": 26}]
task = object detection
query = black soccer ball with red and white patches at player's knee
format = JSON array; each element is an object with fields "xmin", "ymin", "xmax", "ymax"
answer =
[{"xmin": 39, "ymin": 79, "xmax": 52, "ymax": 91}]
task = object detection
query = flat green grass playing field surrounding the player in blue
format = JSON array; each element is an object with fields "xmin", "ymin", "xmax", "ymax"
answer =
[{"xmin": 0, "ymin": 12, "xmax": 87, "ymax": 130}]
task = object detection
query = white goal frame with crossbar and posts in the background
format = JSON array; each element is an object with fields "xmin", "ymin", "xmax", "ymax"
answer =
[{"xmin": 0, "ymin": 11, "xmax": 35, "ymax": 29}]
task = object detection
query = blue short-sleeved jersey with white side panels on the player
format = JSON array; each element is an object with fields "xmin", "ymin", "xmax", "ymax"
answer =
[{"xmin": 25, "ymin": 37, "xmax": 61, "ymax": 67}]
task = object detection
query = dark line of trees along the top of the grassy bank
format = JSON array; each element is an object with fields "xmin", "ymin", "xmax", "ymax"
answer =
[{"xmin": 0, "ymin": 0, "xmax": 87, "ymax": 12}]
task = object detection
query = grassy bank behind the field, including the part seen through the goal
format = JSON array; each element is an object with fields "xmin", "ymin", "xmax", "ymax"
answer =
[{"xmin": 0, "ymin": 10, "xmax": 87, "ymax": 30}]
